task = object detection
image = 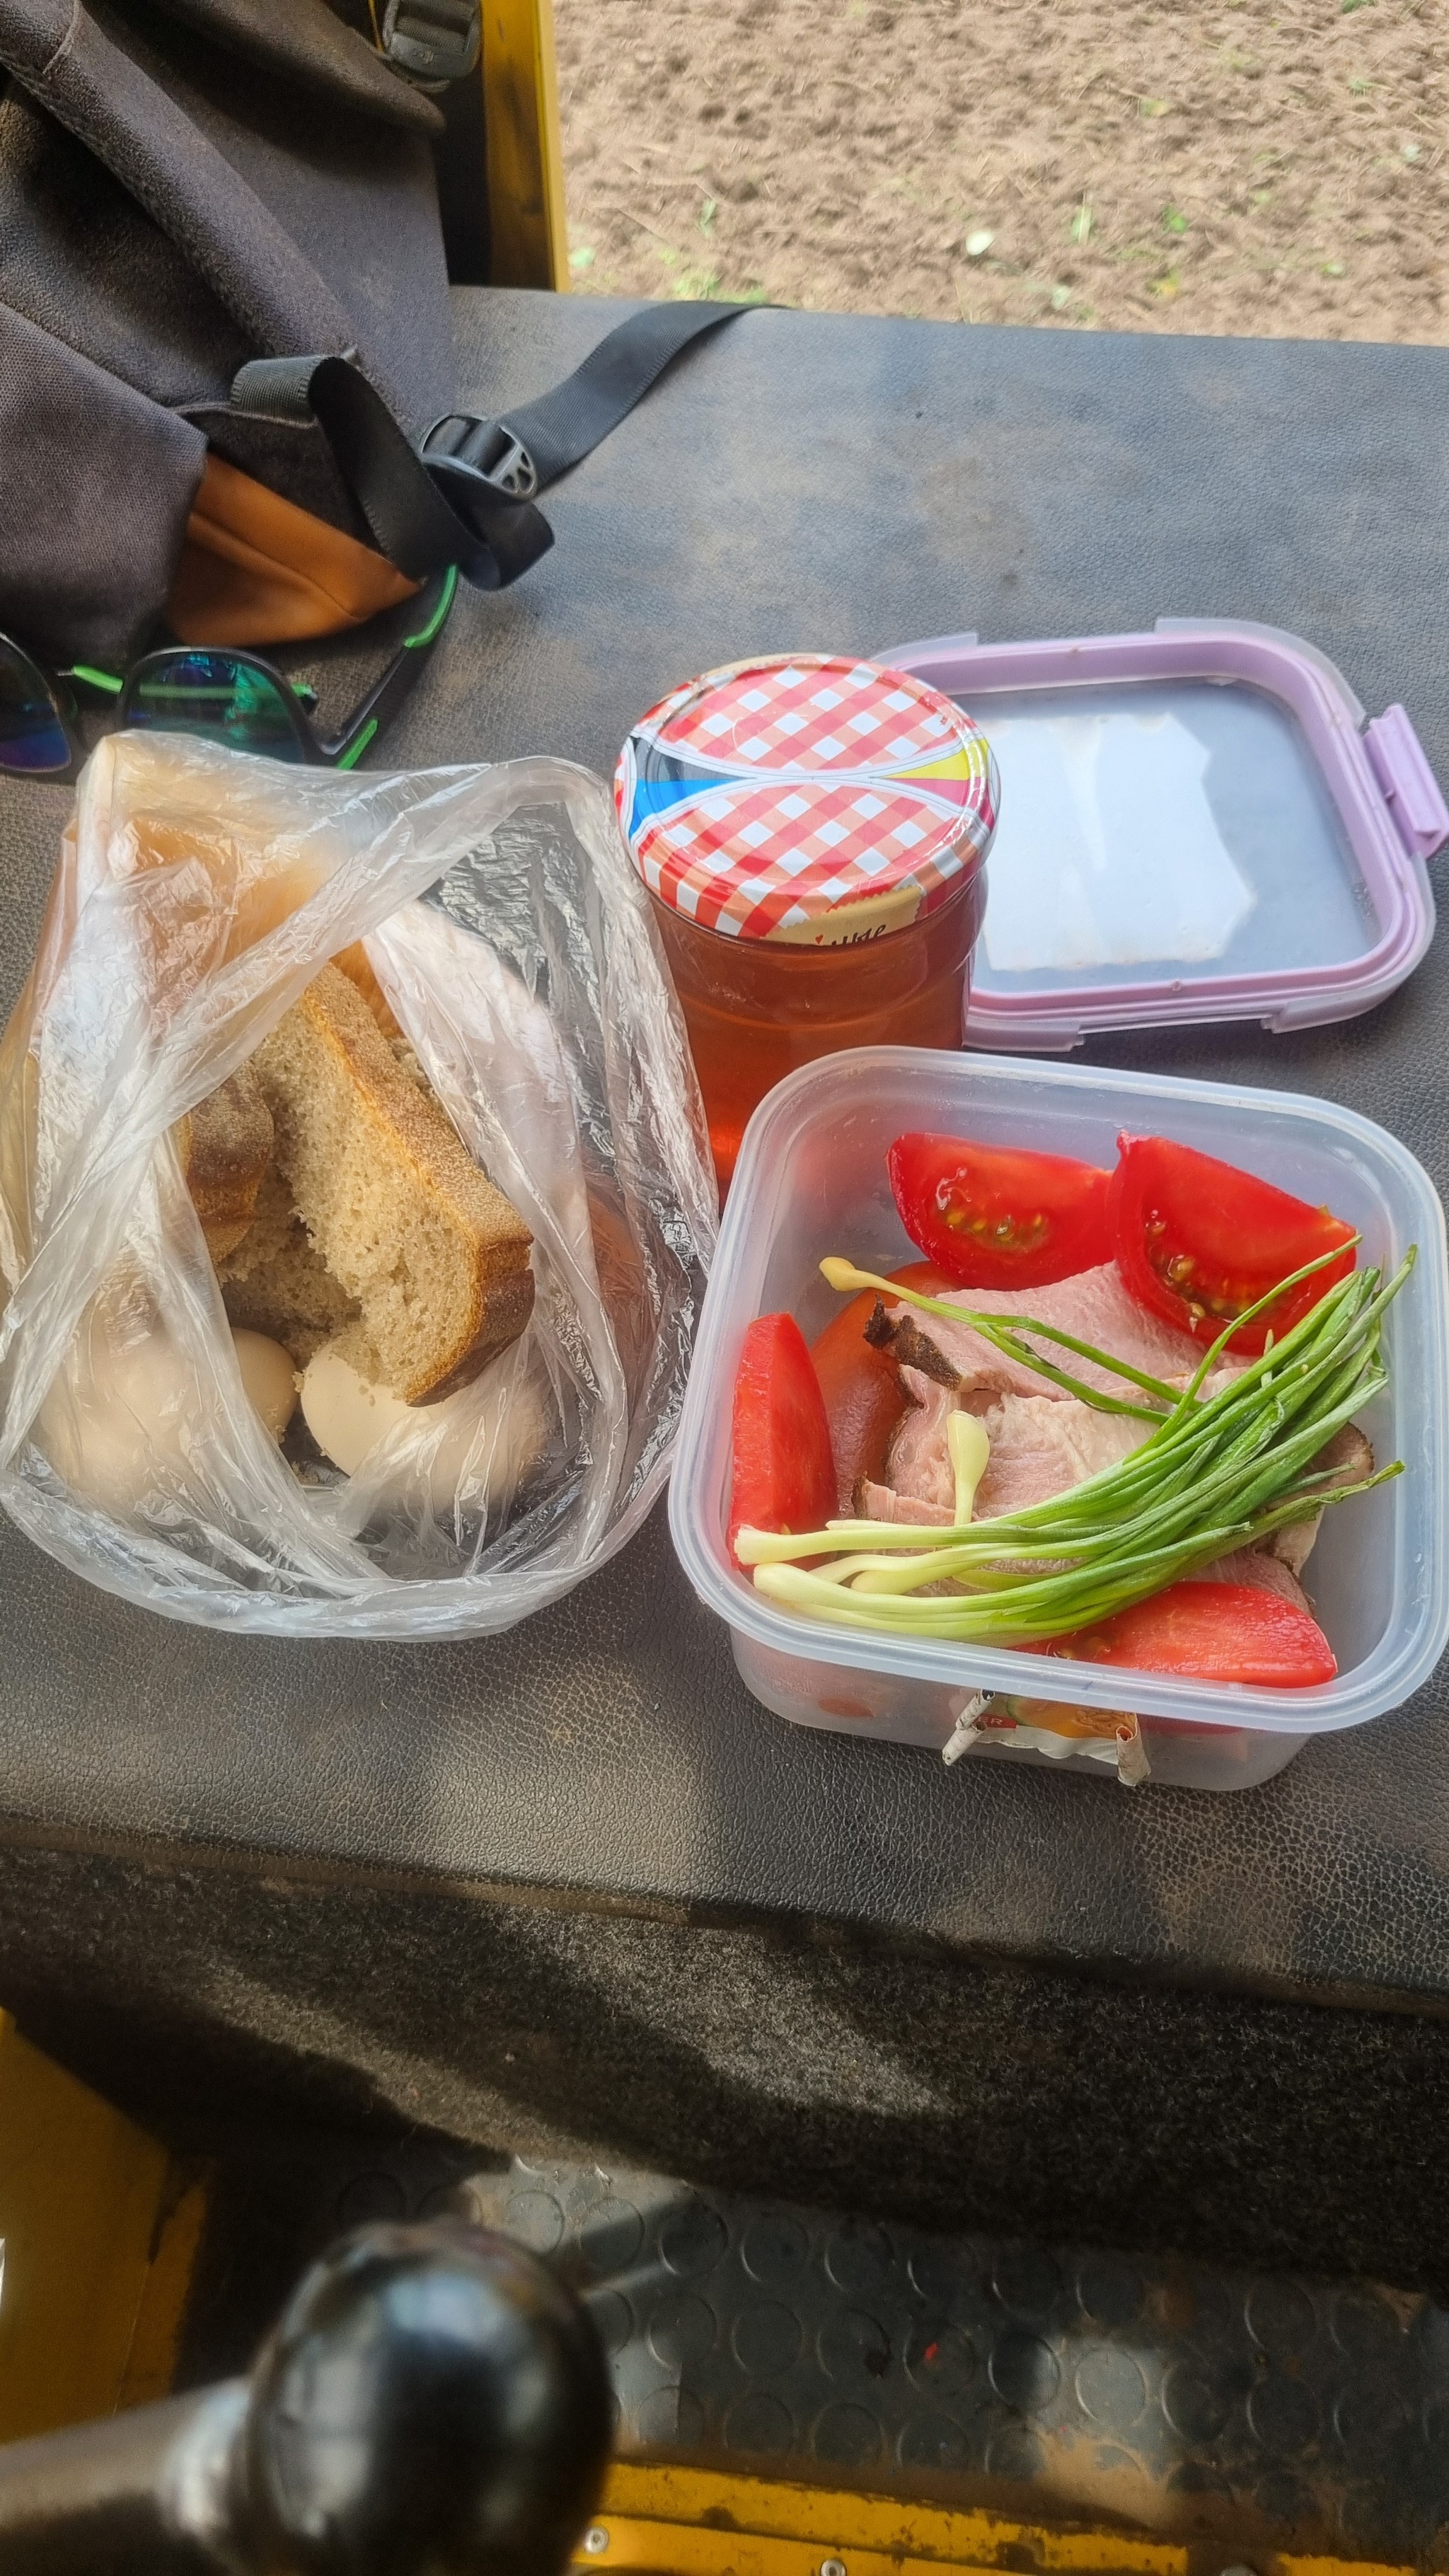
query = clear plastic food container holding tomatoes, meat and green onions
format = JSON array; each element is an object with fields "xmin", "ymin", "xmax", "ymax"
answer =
[{"xmin": 670, "ymin": 1046, "xmax": 1449, "ymax": 1790}]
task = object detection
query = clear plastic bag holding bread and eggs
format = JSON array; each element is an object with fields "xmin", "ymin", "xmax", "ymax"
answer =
[{"xmin": 0, "ymin": 734, "xmax": 717, "ymax": 1639}]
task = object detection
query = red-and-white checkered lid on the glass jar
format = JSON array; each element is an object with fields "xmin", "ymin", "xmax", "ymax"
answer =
[{"xmin": 613, "ymin": 654, "xmax": 1000, "ymax": 948}]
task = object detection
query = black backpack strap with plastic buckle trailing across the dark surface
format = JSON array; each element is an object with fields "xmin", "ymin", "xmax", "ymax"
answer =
[{"xmin": 232, "ymin": 304, "xmax": 753, "ymax": 590}]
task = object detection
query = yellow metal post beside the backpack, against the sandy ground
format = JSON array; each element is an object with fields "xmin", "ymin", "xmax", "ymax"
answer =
[{"xmin": 482, "ymin": 0, "xmax": 570, "ymax": 289}]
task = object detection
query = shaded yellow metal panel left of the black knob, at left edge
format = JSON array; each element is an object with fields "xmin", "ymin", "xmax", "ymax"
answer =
[{"xmin": 0, "ymin": 2012, "xmax": 204, "ymax": 2442}]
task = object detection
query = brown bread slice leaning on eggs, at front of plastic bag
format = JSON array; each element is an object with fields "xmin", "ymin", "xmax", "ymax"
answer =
[{"xmin": 253, "ymin": 966, "xmax": 533, "ymax": 1404}]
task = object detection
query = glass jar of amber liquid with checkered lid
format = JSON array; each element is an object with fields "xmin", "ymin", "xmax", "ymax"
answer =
[{"xmin": 613, "ymin": 654, "xmax": 998, "ymax": 1190}]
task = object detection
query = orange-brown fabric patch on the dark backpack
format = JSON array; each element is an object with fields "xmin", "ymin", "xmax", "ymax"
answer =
[{"xmin": 165, "ymin": 456, "xmax": 423, "ymax": 644}]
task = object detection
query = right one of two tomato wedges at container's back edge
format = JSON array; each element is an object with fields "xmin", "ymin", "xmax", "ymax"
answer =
[{"xmin": 1109, "ymin": 1136, "xmax": 1353, "ymax": 1358}]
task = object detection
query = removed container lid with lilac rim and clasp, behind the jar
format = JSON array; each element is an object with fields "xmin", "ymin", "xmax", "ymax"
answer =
[{"xmin": 887, "ymin": 618, "xmax": 1449, "ymax": 1053}]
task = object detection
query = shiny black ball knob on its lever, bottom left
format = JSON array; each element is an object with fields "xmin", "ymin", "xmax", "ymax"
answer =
[{"xmin": 0, "ymin": 2223, "xmax": 611, "ymax": 2576}]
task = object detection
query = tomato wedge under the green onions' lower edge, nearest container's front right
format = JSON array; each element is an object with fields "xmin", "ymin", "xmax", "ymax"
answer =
[{"xmin": 1032, "ymin": 1584, "xmax": 1338, "ymax": 1690}]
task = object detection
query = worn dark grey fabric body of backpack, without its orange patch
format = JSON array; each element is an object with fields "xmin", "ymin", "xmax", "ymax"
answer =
[{"xmin": 0, "ymin": 0, "xmax": 454, "ymax": 659}]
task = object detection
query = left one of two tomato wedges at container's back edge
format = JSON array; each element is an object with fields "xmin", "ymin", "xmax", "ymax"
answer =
[{"xmin": 887, "ymin": 1136, "xmax": 1112, "ymax": 1288}]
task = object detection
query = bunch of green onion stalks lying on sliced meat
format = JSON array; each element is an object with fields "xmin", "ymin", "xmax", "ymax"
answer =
[{"xmin": 735, "ymin": 1247, "xmax": 1416, "ymax": 1646}]
